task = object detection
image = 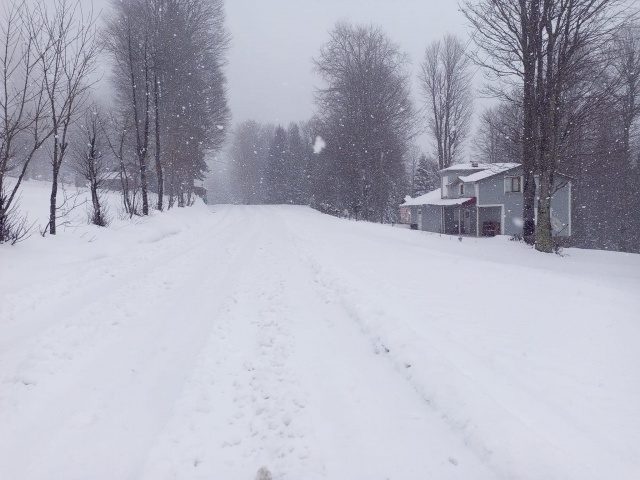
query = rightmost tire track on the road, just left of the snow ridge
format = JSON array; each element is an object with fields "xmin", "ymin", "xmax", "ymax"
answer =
[{"xmin": 268, "ymin": 212, "xmax": 498, "ymax": 479}]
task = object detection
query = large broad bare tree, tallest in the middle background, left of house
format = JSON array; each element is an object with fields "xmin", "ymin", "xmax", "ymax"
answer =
[{"xmin": 315, "ymin": 22, "xmax": 416, "ymax": 221}]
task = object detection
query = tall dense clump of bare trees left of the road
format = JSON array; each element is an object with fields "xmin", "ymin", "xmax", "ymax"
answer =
[{"xmin": 105, "ymin": 0, "xmax": 230, "ymax": 215}]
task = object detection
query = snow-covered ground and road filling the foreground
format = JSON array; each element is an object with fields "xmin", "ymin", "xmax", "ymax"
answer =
[{"xmin": 0, "ymin": 182, "xmax": 640, "ymax": 480}]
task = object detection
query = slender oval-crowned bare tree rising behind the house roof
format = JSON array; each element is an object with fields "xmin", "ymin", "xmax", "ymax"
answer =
[{"xmin": 420, "ymin": 35, "xmax": 473, "ymax": 169}]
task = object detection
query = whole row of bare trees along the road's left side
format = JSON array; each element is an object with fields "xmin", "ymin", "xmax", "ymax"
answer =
[{"xmin": 0, "ymin": 0, "xmax": 230, "ymax": 243}]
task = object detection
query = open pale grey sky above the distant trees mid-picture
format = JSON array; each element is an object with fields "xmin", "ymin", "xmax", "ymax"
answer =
[{"xmin": 226, "ymin": 0, "xmax": 467, "ymax": 124}]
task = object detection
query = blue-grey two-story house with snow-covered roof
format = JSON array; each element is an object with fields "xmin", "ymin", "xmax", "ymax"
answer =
[{"xmin": 400, "ymin": 162, "xmax": 571, "ymax": 237}]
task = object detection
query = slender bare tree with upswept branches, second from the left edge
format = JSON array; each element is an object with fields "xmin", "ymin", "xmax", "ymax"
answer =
[{"xmin": 30, "ymin": 0, "xmax": 99, "ymax": 235}]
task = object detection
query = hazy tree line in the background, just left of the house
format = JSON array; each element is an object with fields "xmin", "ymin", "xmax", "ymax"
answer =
[{"xmin": 229, "ymin": 22, "xmax": 458, "ymax": 222}]
